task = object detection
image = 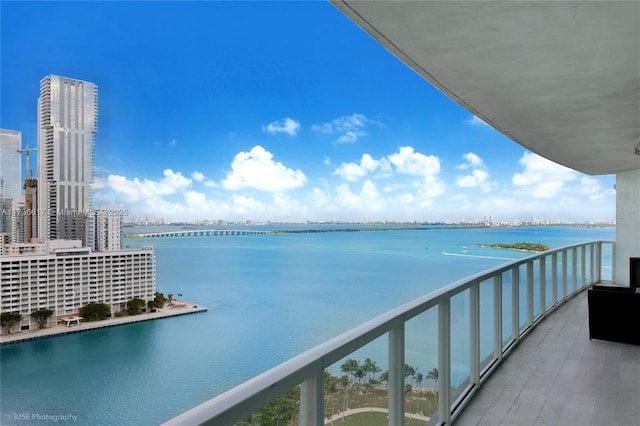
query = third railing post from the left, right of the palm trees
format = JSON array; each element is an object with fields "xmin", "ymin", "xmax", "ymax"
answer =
[{"xmin": 438, "ymin": 298, "xmax": 451, "ymax": 425}]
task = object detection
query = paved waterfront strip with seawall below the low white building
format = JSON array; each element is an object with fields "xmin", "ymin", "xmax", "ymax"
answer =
[{"xmin": 0, "ymin": 299, "xmax": 207, "ymax": 346}]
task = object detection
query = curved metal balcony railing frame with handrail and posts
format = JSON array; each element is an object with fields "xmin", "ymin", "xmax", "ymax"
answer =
[{"xmin": 164, "ymin": 240, "xmax": 615, "ymax": 426}]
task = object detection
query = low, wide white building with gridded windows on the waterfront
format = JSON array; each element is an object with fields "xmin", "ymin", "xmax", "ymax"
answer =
[{"xmin": 0, "ymin": 245, "xmax": 156, "ymax": 330}]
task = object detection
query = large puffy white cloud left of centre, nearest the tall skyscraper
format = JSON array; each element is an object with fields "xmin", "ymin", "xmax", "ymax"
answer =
[{"xmin": 222, "ymin": 145, "xmax": 307, "ymax": 192}]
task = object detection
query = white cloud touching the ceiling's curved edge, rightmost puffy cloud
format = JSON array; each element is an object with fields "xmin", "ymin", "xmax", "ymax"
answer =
[{"xmin": 512, "ymin": 152, "xmax": 578, "ymax": 198}]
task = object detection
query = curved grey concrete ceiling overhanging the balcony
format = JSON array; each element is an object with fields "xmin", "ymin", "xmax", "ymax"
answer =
[{"xmin": 332, "ymin": 0, "xmax": 640, "ymax": 175}]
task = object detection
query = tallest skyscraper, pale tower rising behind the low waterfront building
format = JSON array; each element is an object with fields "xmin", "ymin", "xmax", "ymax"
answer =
[{"xmin": 38, "ymin": 75, "xmax": 98, "ymax": 241}]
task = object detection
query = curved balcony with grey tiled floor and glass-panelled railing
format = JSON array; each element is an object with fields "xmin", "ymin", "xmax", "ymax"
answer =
[{"xmin": 165, "ymin": 241, "xmax": 640, "ymax": 425}]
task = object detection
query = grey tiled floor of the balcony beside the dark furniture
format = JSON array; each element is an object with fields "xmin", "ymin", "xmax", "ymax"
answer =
[{"xmin": 455, "ymin": 291, "xmax": 640, "ymax": 426}]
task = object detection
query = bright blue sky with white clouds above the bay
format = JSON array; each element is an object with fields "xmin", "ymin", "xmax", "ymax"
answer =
[{"xmin": 0, "ymin": 1, "xmax": 615, "ymax": 222}]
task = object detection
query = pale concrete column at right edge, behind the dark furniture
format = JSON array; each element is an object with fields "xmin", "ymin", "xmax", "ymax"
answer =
[{"xmin": 613, "ymin": 169, "xmax": 640, "ymax": 286}]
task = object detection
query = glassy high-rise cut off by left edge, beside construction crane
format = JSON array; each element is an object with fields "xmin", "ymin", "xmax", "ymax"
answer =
[{"xmin": 0, "ymin": 129, "xmax": 22, "ymax": 234}]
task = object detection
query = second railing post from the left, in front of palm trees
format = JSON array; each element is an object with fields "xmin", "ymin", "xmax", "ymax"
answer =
[{"xmin": 388, "ymin": 323, "xmax": 405, "ymax": 426}]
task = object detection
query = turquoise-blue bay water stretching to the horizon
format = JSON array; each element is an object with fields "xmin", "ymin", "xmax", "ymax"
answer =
[{"xmin": 0, "ymin": 225, "xmax": 615, "ymax": 425}]
